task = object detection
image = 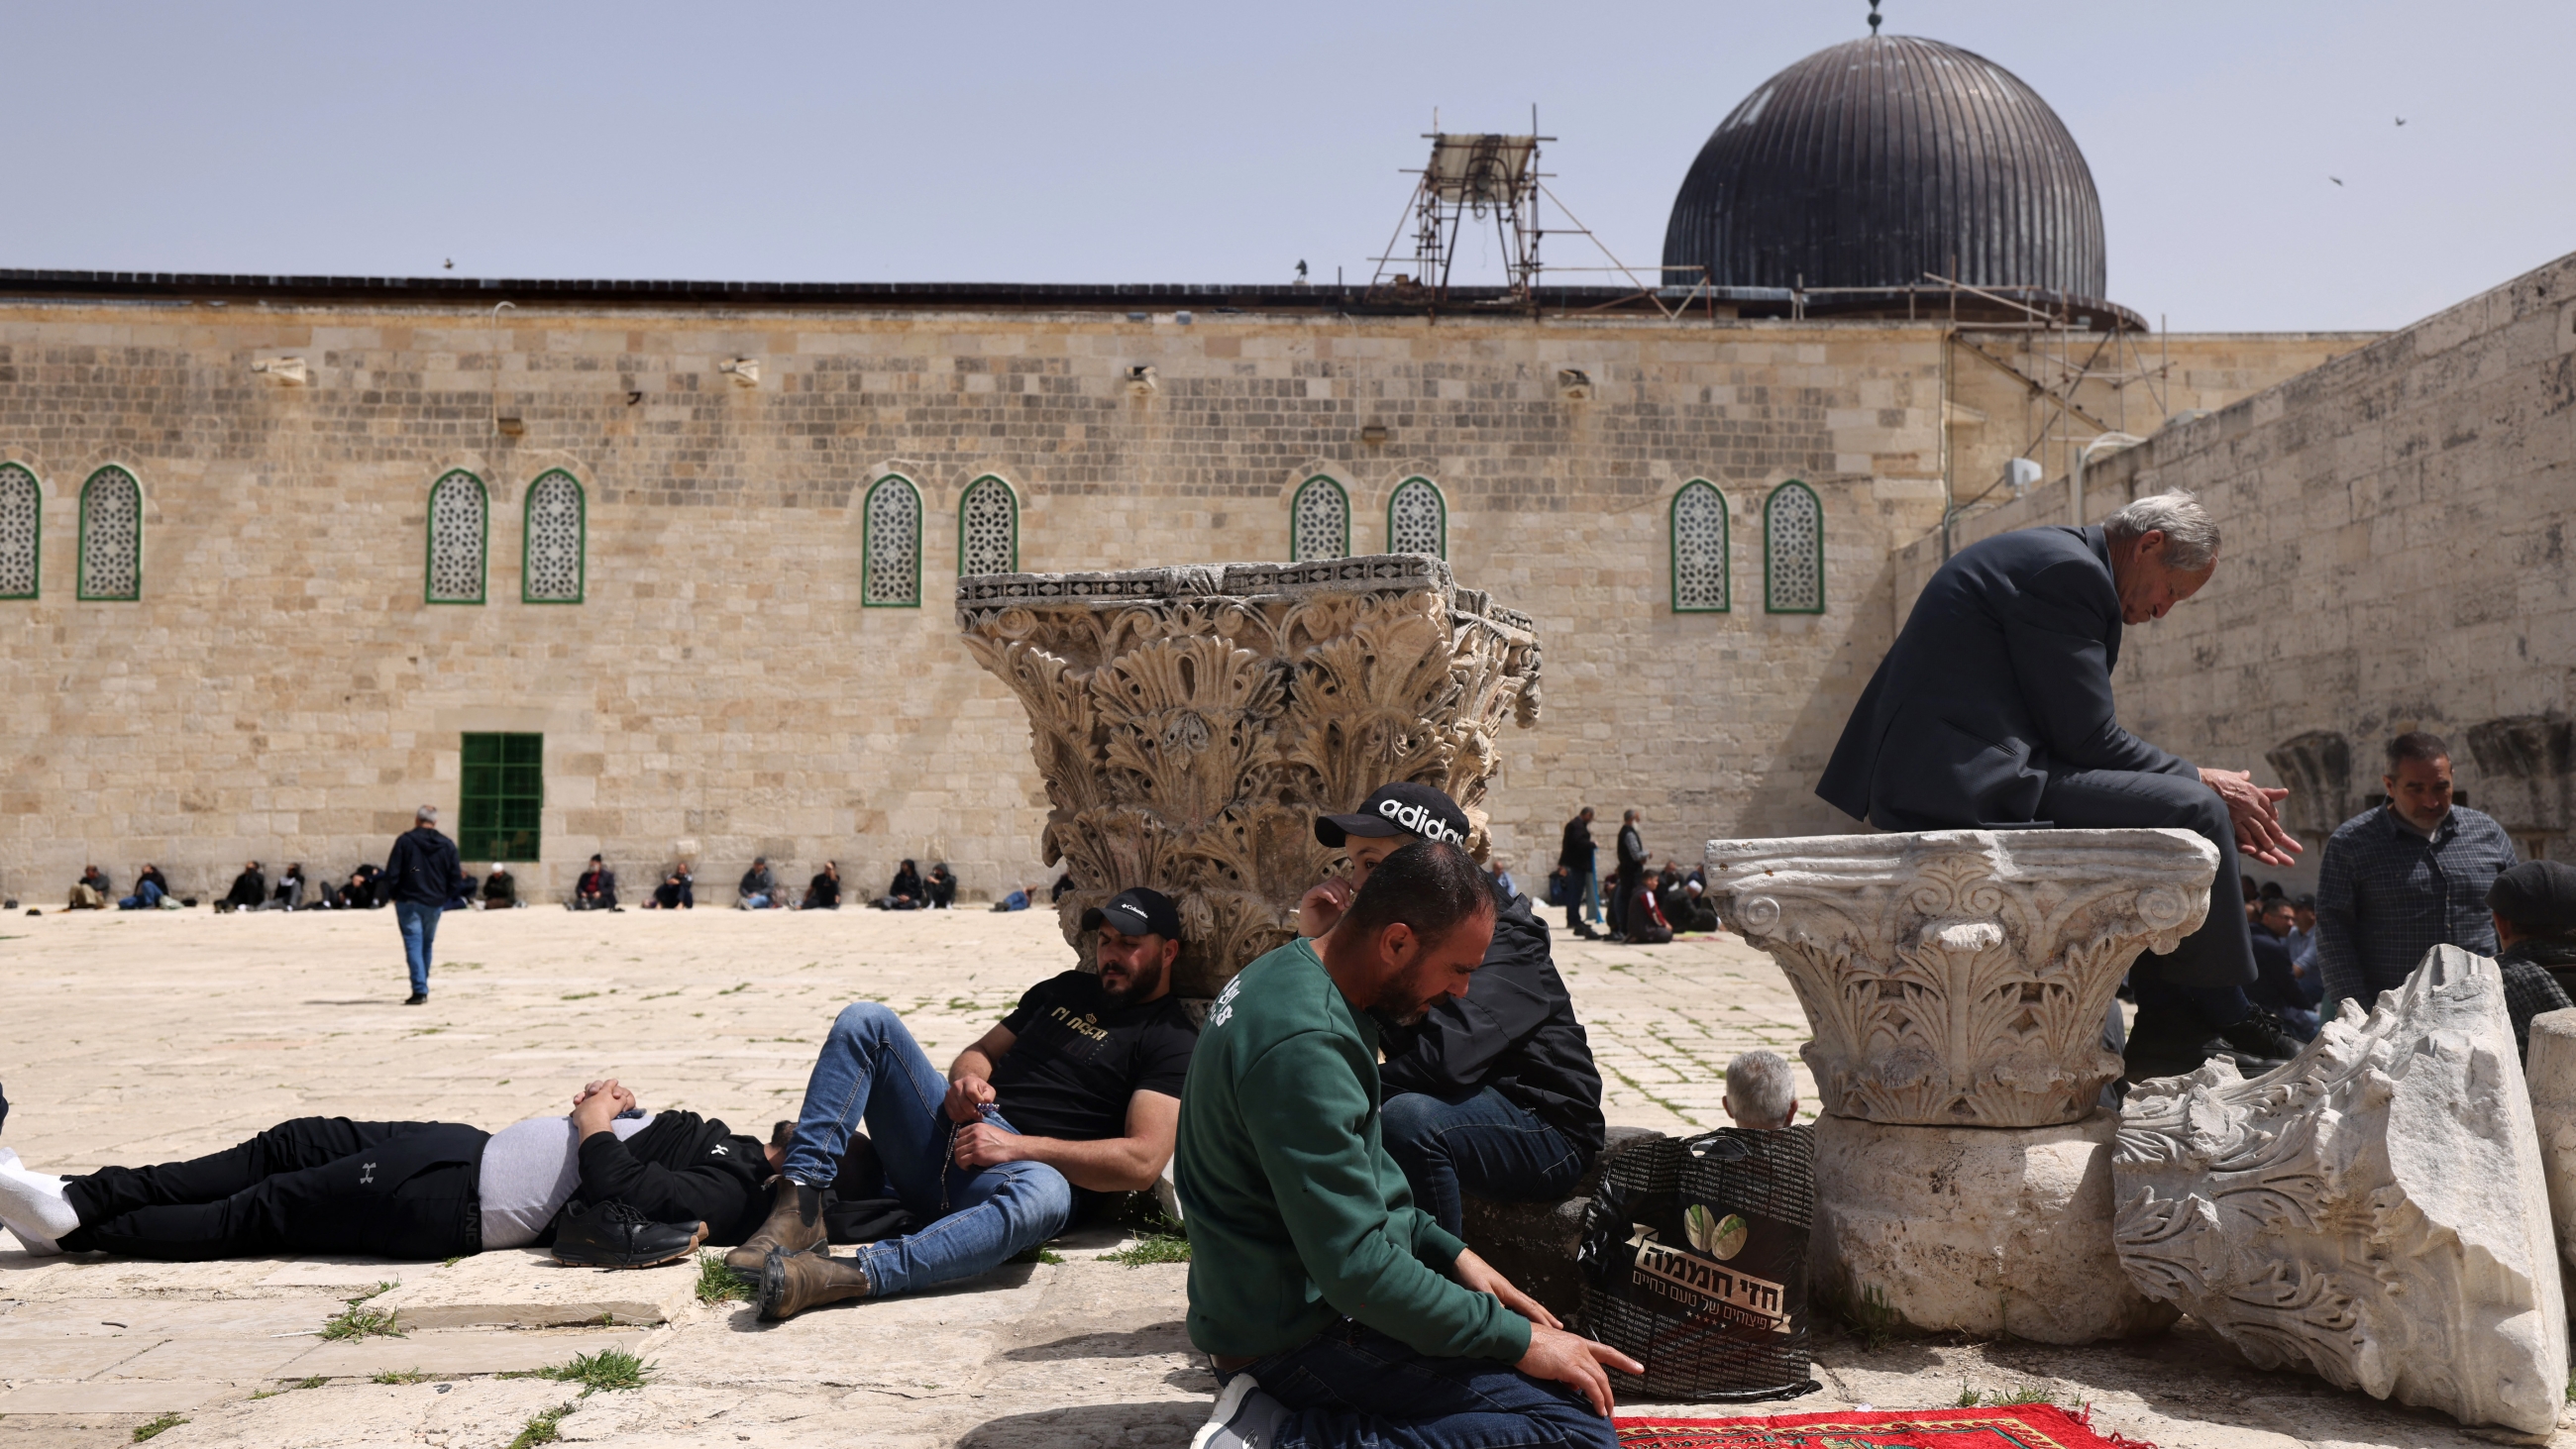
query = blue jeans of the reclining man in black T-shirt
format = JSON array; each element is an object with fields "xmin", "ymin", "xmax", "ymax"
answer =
[{"xmin": 786, "ymin": 1001, "xmax": 1074, "ymax": 1297}]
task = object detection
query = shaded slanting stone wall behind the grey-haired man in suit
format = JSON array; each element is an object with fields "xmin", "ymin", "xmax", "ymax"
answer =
[{"xmin": 1890, "ymin": 258, "xmax": 2576, "ymax": 882}]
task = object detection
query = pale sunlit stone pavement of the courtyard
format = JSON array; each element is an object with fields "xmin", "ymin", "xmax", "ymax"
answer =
[{"xmin": 0, "ymin": 908, "xmax": 2565, "ymax": 1449}]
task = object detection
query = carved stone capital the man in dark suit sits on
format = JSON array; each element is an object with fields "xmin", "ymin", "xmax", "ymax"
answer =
[{"xmin": 1708, "ymin": 831, "xmax": 2218, "ymax": 1127}]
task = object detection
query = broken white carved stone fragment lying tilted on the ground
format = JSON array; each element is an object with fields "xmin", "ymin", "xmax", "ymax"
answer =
[{"xmin": 2112, "ymin": 947, "xmax": 2568, "ymax": 1433}]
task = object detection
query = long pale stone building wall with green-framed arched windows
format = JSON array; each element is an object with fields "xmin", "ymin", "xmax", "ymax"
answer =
[{"xmin": 0, "ymin": 296, "xmax": 2359, "ymax": 903}]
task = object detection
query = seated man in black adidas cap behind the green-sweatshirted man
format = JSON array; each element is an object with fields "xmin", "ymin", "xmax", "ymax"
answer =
[{"xmin": 1298, "ymin": 785, "xmax": 1605, "ymax": 1235}]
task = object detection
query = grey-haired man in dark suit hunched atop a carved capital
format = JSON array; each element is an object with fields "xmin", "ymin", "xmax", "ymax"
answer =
[{"xmin": 1816, "ymin": 491, "xmax": 2301, "ymax": 1081}]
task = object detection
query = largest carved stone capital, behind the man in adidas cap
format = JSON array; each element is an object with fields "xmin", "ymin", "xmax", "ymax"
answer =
[{"xmin": 958, "ymin": 554, "xmax": 1541, "ymax": 996}]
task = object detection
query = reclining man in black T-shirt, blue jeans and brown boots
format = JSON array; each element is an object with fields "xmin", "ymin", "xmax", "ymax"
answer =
[{"xmin": 724, "ymin": 888, "xmax": 1198, "ymax": 1320}]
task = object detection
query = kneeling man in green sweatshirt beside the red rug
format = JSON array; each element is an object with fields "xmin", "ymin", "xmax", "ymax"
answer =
[{"xmin": 1175, "ymin": 842, "xmax": 1644, "ymax": 1449}]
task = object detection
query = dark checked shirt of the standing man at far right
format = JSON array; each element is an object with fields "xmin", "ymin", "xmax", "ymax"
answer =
[{"xmin": 2315, "ymin": 805, "xmax": 2522, "ymax": 1014}]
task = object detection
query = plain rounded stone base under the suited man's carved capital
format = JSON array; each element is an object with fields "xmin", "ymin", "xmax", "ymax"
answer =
[{"xmin": 1808, "ymin": 1112, "xmax": 2174, "ymax": 1343}]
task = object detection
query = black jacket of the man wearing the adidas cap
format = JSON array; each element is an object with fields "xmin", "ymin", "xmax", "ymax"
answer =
[{"xmin": 1378, "ymin": 895, "xmax": 1602, "ymax": 1153}]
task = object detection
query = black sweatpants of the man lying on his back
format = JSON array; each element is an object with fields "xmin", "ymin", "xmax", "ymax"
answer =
[{"xmin": 61, "ymin": 1117, "xmax": 492, "ymax": 1261}]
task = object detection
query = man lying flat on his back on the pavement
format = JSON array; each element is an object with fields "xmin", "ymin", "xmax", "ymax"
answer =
[{"xmin": 0, "ymin": 1081, "xmax": 778, "ymax": 1269}]
